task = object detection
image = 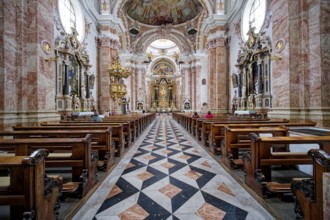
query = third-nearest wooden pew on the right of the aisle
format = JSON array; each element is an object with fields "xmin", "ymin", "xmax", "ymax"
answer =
[{"xmin": 221, "ymin": 125, "xmax": 288, "ymax": 169}]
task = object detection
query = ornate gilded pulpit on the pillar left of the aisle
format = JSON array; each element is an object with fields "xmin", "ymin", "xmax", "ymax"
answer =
[{"xmin": 108, "ymin": 55, "xmax": 132, "ymax": 101}]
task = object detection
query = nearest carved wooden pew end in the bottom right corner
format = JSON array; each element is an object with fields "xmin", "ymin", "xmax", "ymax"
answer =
[{"xmin": 291, "ymin": 149, "xmax": 330, "ymax": 220}]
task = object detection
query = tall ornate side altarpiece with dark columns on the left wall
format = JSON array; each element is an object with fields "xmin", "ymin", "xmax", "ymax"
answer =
[{"xmin": 55, "ymin": 29, "xmax": 95, "ymax": 120}]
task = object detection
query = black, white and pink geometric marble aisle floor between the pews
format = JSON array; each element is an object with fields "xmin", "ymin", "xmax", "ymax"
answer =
[{"xmin": 73, "ymin": 116, "xmax": 274, "ymax": 220}]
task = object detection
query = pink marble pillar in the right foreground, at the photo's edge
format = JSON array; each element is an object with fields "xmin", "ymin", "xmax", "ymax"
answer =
[{"xmin": 269, "ymin": 0, "xmax": 330, "ymax": 127}]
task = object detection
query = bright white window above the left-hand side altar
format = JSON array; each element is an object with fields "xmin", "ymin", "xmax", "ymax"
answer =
[{"xmin": 58, "ymin": 0, "xmax": 85, "ymax": 42}]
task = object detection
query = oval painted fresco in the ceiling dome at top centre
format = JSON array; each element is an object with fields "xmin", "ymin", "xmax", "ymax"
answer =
[{"xmin": 124, "ymin": 0, "xmax": 203, "ymax": 26}]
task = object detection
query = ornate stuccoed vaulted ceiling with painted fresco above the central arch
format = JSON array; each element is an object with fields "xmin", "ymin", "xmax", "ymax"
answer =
[{"xmin": 96, "ymin": 0, "xmax": 241, "ymax": 55}]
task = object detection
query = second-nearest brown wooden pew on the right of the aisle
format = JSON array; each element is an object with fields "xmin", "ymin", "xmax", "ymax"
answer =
[{"xmin": 243, "ymin": 133, "xmax": 330, "ymax": 197}]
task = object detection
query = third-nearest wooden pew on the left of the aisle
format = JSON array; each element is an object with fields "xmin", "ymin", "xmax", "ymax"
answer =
[{"xmin": 0, "ymin": 126, "xmax": 115, "ymax": 170}]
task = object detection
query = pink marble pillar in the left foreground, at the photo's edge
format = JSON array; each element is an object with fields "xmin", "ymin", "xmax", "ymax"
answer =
[{"xmin": 0, "ymin": 0, "xmax": 60, "ymax": 129}]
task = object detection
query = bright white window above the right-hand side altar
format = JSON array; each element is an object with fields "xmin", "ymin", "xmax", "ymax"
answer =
[{"xmin": 241, "ymin": 0, "xmax": 266, "ymax": 41}]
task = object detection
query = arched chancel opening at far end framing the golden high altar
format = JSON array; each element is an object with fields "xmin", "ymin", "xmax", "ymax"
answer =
[{"xmin": 144, "ymin": 39, "xmax": 181, "ymax": 112}]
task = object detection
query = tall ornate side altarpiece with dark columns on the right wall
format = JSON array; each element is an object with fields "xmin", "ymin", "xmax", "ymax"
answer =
[{"xmin": 232, "ymin": 29, "xmax": 272, "ymax": 118}]
